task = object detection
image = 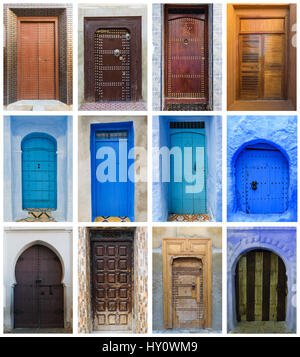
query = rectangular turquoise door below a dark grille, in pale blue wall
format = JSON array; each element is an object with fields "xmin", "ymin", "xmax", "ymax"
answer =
[{"xmin": 169, "ymin": 122, "xmax": 206, "ymax": 214}]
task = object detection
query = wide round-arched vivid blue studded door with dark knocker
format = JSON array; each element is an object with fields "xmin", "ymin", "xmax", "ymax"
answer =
[{"xmin": 236, "ymin": 143, "xmax": 289, "ymax": 214}]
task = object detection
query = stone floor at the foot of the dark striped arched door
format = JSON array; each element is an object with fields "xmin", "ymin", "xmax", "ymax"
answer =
[{"xmin": 231, "ymin": 321, "xmax": 292, "ymax": 334}]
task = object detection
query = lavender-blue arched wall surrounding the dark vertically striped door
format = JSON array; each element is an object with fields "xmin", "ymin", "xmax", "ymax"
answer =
[{"xmin": 227, "ymin": 227, "xmax": 297, "ymax": 331}]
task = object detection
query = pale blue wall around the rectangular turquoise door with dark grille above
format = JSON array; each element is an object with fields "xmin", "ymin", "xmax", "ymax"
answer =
[{"xmin": 152, "ymin": 116, "xmax": 222, "ymax": 222}]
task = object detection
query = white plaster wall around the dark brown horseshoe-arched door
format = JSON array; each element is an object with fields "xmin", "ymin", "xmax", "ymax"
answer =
[{"xmin": 3, "ymin": 228, "xmax": 73, "ymax": 331}]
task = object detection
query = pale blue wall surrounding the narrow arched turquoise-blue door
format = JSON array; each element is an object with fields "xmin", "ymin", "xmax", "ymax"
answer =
[{"xmin": 4, "ymin": 115, "xmax": 73, "ymax": 222}]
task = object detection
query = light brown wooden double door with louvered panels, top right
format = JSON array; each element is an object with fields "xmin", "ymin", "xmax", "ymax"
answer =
[{"xmin": 237, "ymin": 18, "xmax": 287, "ymax": 100}]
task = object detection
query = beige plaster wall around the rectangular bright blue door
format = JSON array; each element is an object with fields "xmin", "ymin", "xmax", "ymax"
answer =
[{"xmin": 78, "ymin": 116, "xmax": 147, "ymax": 222}]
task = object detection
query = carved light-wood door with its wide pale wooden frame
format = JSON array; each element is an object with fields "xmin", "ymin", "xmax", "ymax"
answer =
[{"xmin": 163, "ymin": 238, "xmax": 212, "ymax": 328}]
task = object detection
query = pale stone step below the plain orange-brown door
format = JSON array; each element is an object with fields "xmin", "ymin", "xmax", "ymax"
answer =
[{"xmin": 5, "ymin": 100, "xmax": 72, "ymax": 111}]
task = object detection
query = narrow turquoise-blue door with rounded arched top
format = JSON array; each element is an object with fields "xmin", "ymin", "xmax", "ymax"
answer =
[{"xmin": 21, "ymin": 133, "xmax": 57, "ymax": 210}]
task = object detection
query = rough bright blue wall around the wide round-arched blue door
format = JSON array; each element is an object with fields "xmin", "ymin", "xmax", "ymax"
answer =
[{"xmin": 227, "ymin": 116, "xmax": 297, "ymax": 222}]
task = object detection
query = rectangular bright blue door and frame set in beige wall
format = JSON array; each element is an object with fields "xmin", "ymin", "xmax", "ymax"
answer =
[{"xmin": 91, "ymin": 122, "xmax": 134, "ymax": 221}]
